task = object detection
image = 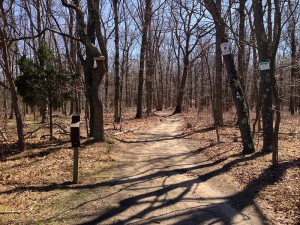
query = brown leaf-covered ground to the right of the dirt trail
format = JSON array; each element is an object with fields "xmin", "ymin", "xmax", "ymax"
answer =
[{"xmin": 182, "ymin": 108, "xmax": 300, "ymax": 224}]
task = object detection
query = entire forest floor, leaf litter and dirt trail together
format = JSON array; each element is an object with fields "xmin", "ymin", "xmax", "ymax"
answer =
[{"xmin": 0, "ymin": 108, "xmax": 300, "ymax": 224}]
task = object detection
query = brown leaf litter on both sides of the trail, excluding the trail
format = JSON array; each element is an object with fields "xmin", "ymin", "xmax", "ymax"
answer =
[{"xmin": 0, "ymin": 110, "xmax": 300, "ymax": 224}]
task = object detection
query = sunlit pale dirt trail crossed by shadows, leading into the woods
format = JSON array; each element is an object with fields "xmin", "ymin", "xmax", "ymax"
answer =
[{"xmin": 75, "ymin": 117, "xmax": 263, "ymax": 225}]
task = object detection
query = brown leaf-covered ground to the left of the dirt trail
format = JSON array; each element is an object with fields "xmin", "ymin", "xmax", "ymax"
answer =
[{"xmin": 0, "ymin": 109, "xmax": 159, "ymax": 224}]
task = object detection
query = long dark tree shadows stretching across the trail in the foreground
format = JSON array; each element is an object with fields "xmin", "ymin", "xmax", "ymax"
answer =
[{"xmin": 0, "ymin": 143, "xmax": 294, "ymax": 225}]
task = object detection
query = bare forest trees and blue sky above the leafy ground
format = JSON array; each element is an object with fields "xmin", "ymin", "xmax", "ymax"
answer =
[{"xmin": 0, "ymin": 0, "xmax": 300, "ymax": 161}]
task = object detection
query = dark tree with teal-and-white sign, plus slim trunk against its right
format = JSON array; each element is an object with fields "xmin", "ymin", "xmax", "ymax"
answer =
[{"xmin": 252, "ymin": 0, "xmax": 282, "ymax": 164}]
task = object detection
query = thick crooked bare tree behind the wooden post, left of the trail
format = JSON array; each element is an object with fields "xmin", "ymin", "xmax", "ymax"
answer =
[{"xmin": 61, "ymin": 0, "xmax": 107, "ymax": 141}]
